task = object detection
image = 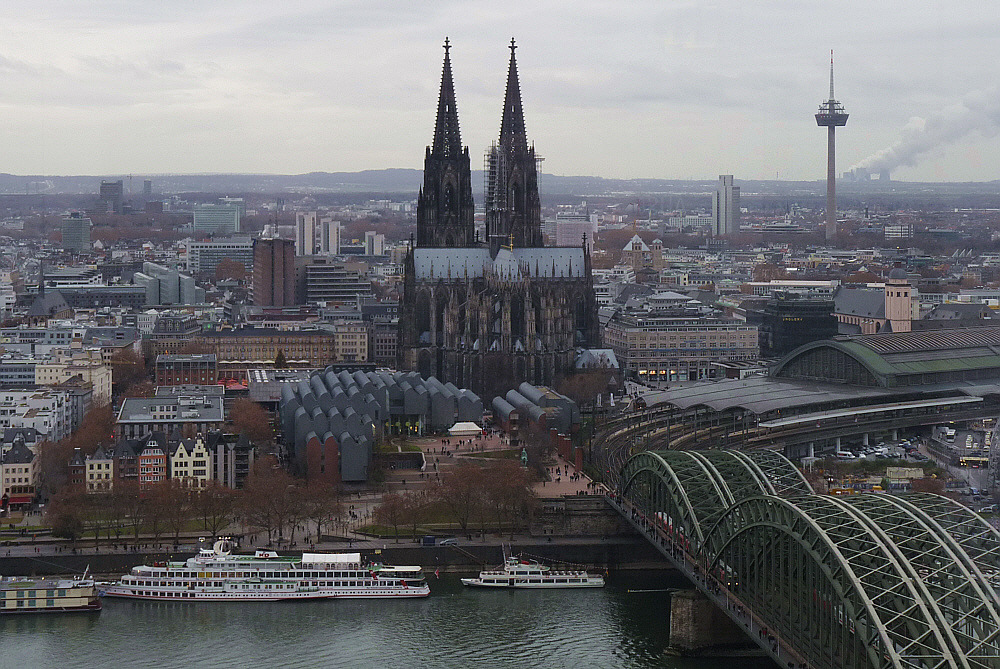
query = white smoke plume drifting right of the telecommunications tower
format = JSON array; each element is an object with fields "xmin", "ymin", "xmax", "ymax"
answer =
[{"xmin": 851, "ymin": 86, "xmax": 1000, "ymax": 174}]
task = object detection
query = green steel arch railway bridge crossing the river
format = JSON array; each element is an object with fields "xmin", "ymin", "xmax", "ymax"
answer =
[{"xmin": 608, "ymin": 450, "xmax": 1000, "ymax": 669}]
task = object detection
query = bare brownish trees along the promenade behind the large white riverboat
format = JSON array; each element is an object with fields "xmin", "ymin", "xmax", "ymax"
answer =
[{"xmin": 47, "ymin": 458, "xmax": 342, "ymax": 547}]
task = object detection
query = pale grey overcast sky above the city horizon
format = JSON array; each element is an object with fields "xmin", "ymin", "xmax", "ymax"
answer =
[{"xmin": 0, "ymin": 0, "xmax": 1000, "ymax": 181}]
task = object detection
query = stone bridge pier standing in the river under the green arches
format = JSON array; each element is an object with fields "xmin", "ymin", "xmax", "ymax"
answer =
[{"xmin": 667, "ymin": 590, "xmax": 763, "ymax": 656}]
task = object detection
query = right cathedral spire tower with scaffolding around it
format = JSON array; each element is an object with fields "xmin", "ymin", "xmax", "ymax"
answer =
[{"xmin": 486, "ymin": 39, "xmax": 542, "ymax": 257}]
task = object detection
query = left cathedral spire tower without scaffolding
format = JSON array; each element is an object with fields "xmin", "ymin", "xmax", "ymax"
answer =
[{"xmin": 417, "ymin": 39, "xmax": 476, "ymax": 248}]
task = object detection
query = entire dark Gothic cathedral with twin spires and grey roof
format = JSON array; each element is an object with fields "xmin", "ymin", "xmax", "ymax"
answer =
[{"xmin": 398, "ymin": 40, "xmax": 599, "ymax": 398}]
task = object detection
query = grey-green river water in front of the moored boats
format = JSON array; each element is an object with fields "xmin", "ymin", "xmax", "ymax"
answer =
[{"xmin": 0, "ymin": 572, "xmax": 774, "ymax": 669}]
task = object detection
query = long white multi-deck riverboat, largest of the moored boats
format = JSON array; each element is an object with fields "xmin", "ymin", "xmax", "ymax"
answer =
[{"xmin": 102, "ymin": 540, "xmax": 430, "ymax": 602}]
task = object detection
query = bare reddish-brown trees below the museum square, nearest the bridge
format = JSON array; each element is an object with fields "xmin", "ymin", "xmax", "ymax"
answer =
[{"xmin": 374, "ymin": 459, "xmax": 535, "ymax": 541}]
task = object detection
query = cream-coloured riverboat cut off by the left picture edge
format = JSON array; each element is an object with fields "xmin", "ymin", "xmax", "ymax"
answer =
[{"xmin": 0, "ymin": 572, "xmax": 101, "ymax": 615}]
